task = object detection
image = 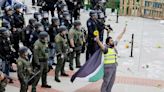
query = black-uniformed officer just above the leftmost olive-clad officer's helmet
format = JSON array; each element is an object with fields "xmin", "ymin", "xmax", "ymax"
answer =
[{"xmin": 21, "ymin": 18, "xmax": 36, "ymax": 50}]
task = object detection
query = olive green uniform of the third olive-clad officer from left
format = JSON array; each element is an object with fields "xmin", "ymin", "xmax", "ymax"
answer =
[{"xmin": 55, "ymin": 34, "xmax": 69, "ymax": 78}]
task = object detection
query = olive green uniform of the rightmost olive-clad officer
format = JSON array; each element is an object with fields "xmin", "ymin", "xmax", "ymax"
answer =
[{"xmin": 69, "ymin": 27, "xmax": 84, "ymax": 67}]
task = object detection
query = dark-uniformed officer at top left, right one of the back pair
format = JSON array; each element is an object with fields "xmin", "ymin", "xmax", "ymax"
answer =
[{"xmin": 13, "ymin": 4, "xmax": 25, "ymax": 29}]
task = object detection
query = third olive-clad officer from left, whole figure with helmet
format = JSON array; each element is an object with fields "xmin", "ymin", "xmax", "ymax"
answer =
[{"xmin": 55, "ymin": 26, "xmax": 69, "ymax": 82}]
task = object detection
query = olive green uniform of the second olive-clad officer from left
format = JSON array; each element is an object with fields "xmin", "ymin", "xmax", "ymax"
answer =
[{"xmin": 33, "ymin": 39, "xmax": 48, "ymax": 85}]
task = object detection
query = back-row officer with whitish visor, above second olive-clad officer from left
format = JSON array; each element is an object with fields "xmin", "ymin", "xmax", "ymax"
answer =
[{"xmin": 41, "ymin": 12, "xmax": 50, "ymax": 32}]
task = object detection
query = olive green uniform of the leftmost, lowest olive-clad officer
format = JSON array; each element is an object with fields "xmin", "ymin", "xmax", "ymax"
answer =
[{"xmin": 17, "ymin": 57, "xmax": 32, "ymax": 92}]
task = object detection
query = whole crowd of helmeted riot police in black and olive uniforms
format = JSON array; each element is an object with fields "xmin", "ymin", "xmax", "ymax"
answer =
[{"xmin": 0, "ymin": 0, "xmax": 110, "ymax": 92}]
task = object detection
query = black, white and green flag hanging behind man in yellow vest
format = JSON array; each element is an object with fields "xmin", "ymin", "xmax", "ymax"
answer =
[{"xmin": 71, "ymin": 49, "xmax": 104, "ymax": 82}]
